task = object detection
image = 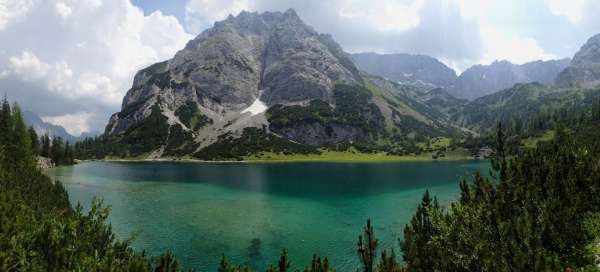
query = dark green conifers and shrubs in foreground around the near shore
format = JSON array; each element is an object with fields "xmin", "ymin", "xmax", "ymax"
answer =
[{"xmin": 0, "ymin": 91, "xmax": 600, "ymax": 272}]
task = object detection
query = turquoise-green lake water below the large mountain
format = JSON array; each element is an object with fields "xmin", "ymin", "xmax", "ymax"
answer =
[{"xmin": 49, "ymin": 161, "xmax": 489, "ymax": 271}]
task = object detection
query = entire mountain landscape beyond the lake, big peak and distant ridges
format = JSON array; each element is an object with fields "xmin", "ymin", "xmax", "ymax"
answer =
[{"xmin": 80, "ymin": 9, "xmax": 600, "ymax": 160}]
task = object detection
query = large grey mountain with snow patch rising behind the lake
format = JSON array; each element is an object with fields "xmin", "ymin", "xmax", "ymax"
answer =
[{"xmin": 105, "ymin": 9, "xmax": 454, "ymax": 159}]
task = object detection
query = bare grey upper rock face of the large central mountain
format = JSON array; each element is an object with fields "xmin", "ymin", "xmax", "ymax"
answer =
[{"xmin": 107, "ymin": 10, "xmax": 362, "ymax": 134}]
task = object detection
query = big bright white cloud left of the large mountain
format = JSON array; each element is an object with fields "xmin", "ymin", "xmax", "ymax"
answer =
[{"xmin": 0, "ymin": 0, "xmax": 193, "ymax": 133}]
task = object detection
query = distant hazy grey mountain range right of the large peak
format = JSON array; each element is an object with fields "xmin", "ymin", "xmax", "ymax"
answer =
[{"xmin": 352, "ymin": 53, "xmax": 571, "ymax": 100}]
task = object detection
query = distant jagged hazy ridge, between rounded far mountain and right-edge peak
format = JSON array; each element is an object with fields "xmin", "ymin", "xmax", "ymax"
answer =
[{"xmin": 448, "ymin": 59, "xmax": 570, "ymax": 100}]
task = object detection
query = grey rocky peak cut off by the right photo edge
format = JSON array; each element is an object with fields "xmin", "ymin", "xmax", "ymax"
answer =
[{"xmin": 556, "ymin": 34, "xmax": 600, "ymax": 88}]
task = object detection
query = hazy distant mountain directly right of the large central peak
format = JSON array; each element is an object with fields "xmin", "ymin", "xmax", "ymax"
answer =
[{"xmin": 352, "ymin": 53, "xmax": 457, "ymax": 89}]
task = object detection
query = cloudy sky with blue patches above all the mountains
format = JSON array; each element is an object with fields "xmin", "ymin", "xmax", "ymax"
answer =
[{"xmin": 0, "ymin": 0, "xmax": 600, "ymax": 136}]
